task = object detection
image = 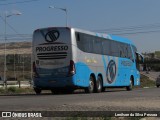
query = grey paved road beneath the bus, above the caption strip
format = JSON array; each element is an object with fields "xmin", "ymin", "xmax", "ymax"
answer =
[{"xmin": 0, "ymin": 88, "xmax": 160, "ymax": 111}]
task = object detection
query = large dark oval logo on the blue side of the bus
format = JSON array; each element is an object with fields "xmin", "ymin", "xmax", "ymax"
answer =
[{"xmin": 106, "ymin": 60, "xmax": 117, "ymax": 84}]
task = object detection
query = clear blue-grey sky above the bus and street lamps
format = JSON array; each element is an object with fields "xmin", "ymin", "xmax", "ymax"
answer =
[{"xmin": 0, "ymin": 0, "xmax": 160, "ymax": 52}]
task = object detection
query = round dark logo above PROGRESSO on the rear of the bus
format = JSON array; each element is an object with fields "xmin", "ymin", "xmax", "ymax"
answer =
[{"xmin": 45, "ymin": 30, "xmax": 60, "ymax": 43}]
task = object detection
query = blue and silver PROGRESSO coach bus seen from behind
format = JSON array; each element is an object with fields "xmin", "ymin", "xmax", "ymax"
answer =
[{"xmin": 32, "ymin": 27, "xmax": 142, "ymax": 94}]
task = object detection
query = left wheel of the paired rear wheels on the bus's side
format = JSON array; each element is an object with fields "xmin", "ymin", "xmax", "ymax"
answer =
[{"xmin": 85, "ymin": 76, "xmax": 95, "ymax": 93}]
